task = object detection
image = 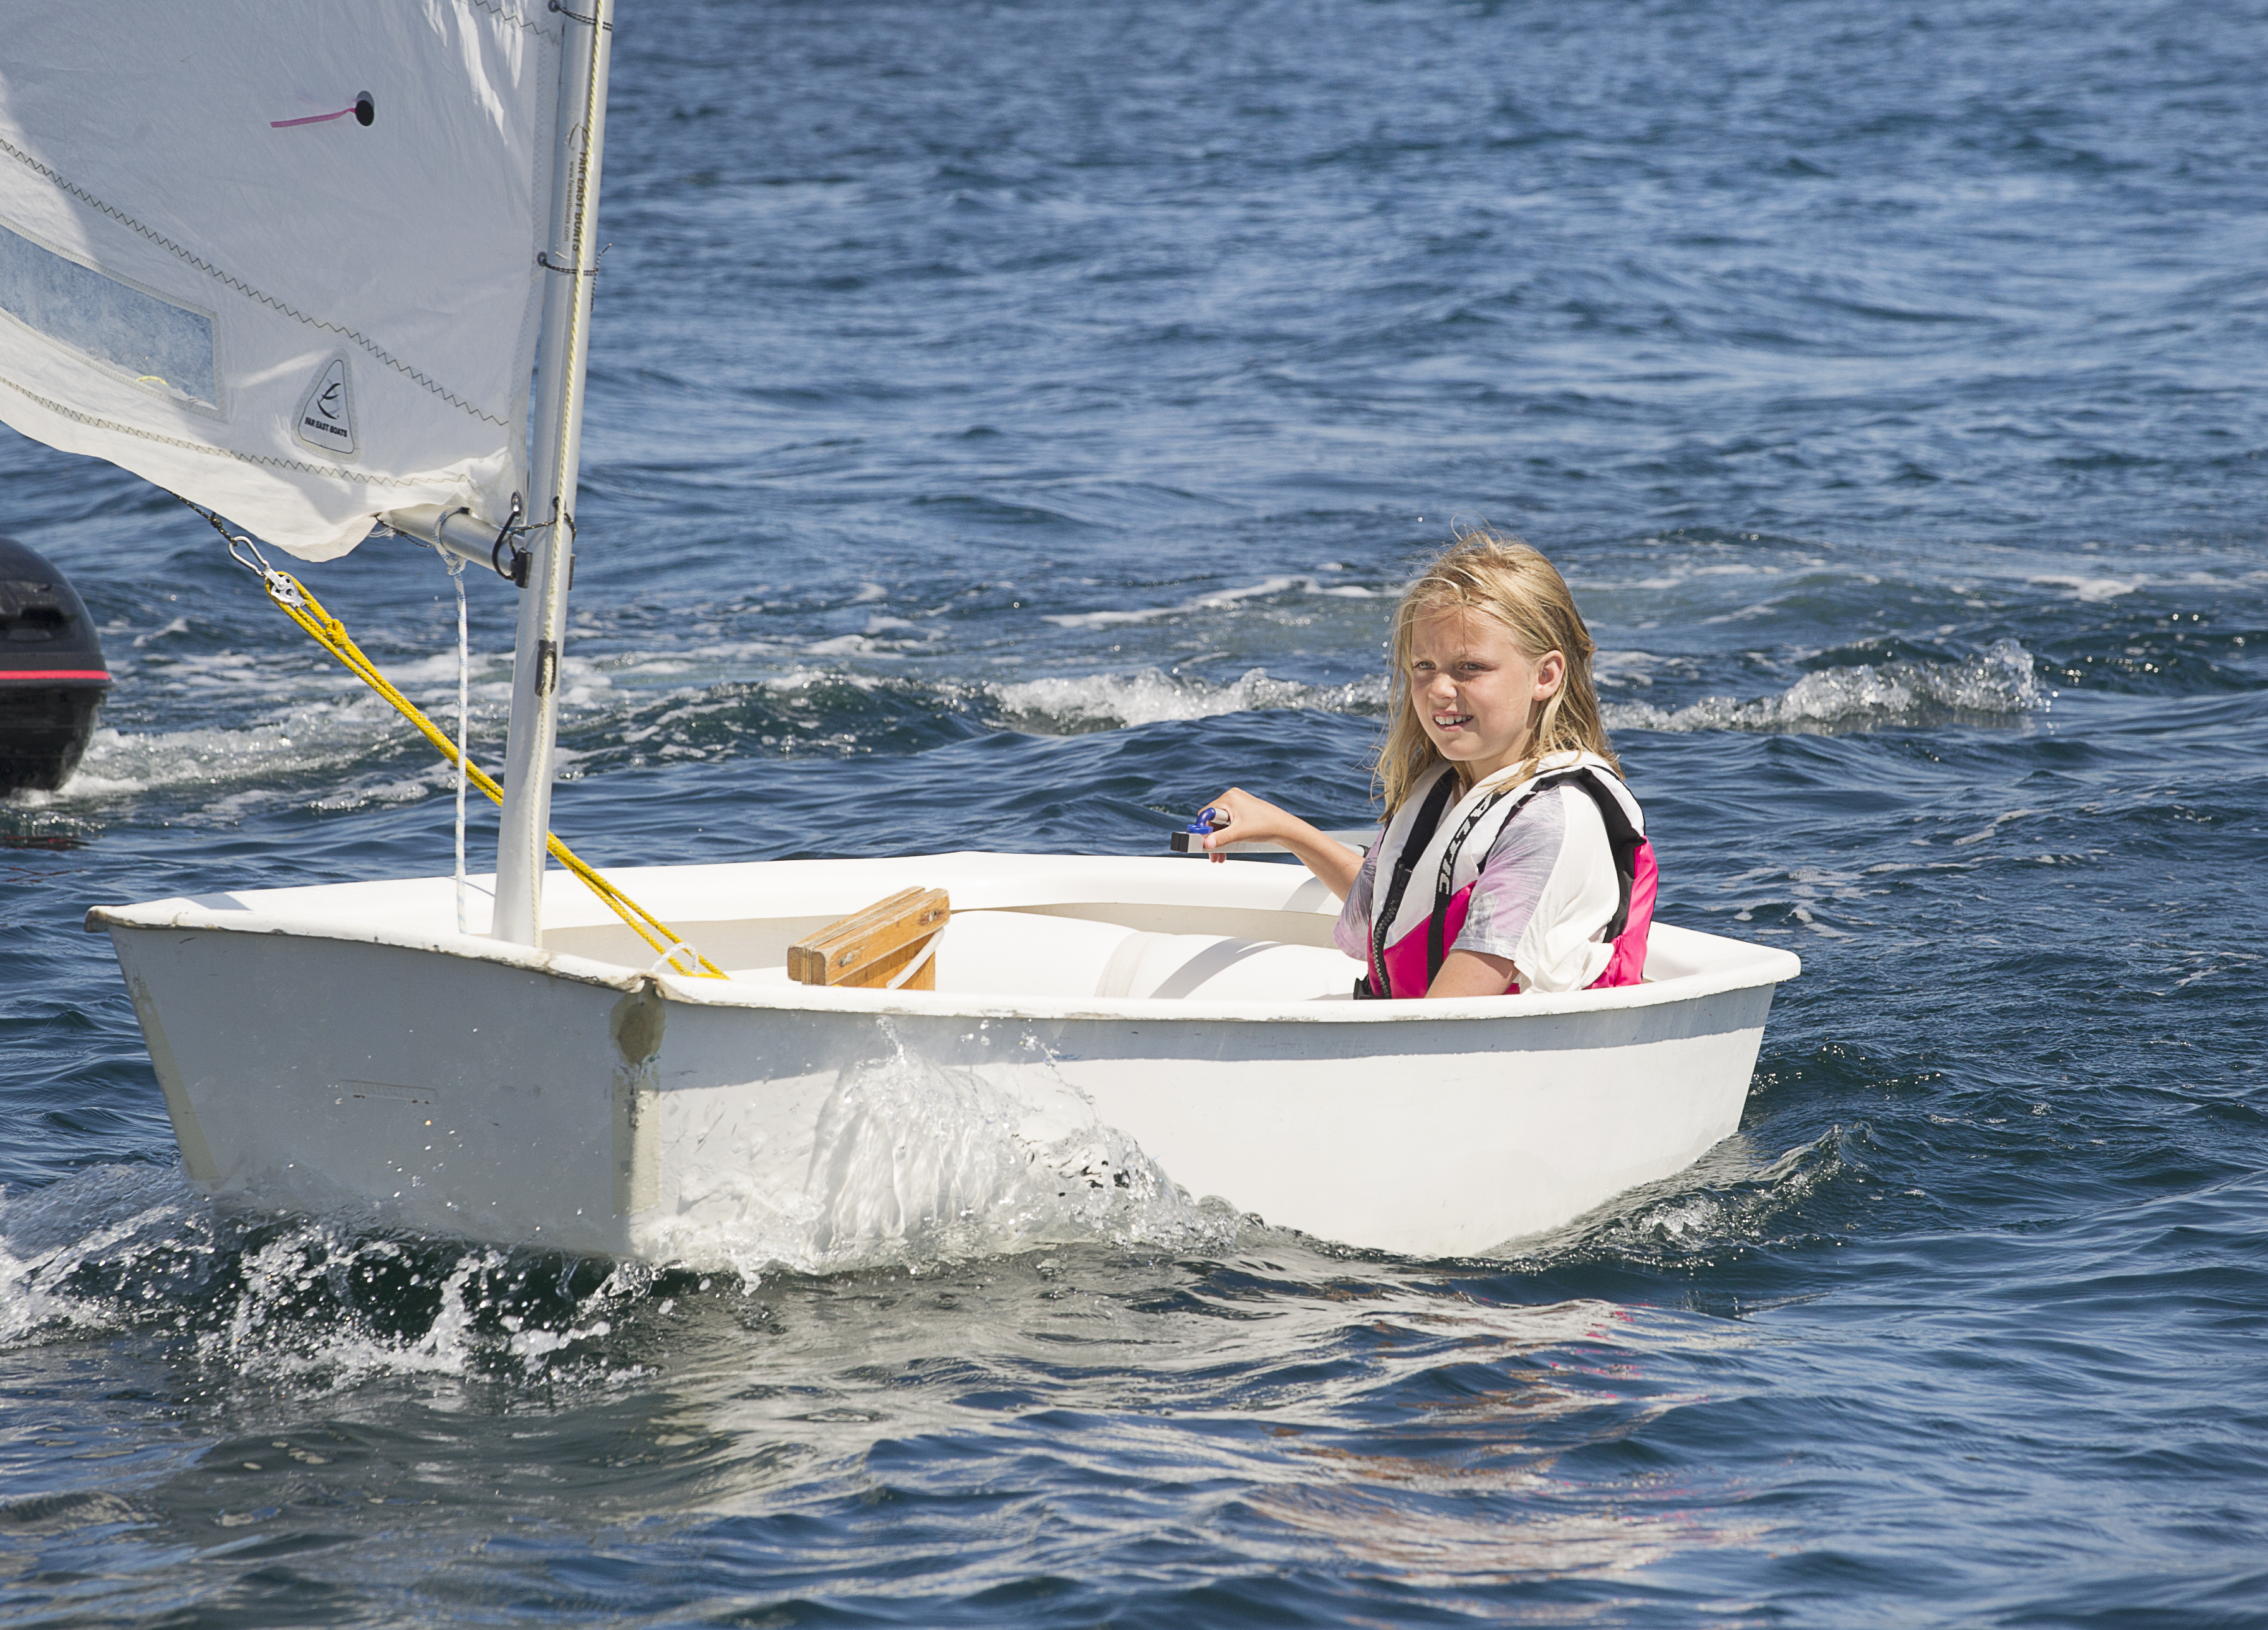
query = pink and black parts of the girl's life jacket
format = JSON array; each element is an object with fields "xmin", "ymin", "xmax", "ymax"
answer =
[{"xmin": 1354, "ymin": 766, "xmax": 1658, "ymax": 998}]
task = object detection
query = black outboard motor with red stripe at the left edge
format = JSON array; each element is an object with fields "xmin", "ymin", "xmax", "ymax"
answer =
[{"xmin": 0, "ymin": 537, "xmax": 111, "ymax": 793}]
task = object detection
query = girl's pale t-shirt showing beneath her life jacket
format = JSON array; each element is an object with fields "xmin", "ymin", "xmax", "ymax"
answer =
[{"xmin": 1331, "ymin": 784, "xmax": 1622, "ymax": 991}]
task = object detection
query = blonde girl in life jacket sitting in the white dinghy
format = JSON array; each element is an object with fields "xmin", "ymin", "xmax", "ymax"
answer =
[{"xmin": 1204, "ymin": 533, "xmax": 1653, "ymax": 998}]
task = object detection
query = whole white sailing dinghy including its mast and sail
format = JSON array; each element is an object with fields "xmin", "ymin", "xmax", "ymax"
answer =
[{"xmin": 0, "ymin": 0, "xmax": 1798, "ymax": 1260}]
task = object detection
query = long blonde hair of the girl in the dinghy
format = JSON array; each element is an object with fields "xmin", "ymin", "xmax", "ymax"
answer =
[{"xmin": 1377, "ymin": 533, "xmax": 1622, "ymax": 820}]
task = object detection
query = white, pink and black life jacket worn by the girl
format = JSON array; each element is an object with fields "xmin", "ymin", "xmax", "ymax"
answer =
[{"xmin": 1354, "ymin": 753, "xmax": 1656, "ymax": 998}]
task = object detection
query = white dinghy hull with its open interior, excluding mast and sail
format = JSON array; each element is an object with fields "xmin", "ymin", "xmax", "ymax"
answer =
[{"xmin": 88, "ymin": 854, "xmax": 1798, "ymax": 1260}]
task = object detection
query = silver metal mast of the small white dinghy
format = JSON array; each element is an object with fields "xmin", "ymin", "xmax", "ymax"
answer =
[{"xmin": 490, "ymin": 0, "xmax": 615, "ymax": 945}]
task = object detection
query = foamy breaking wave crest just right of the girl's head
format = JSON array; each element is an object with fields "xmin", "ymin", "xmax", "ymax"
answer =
[{"xmin": 1601, "ymin": 639, "xmax": 2048, "ymax": 732}]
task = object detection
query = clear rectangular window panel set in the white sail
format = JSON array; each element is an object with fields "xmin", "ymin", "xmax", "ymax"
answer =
[{"xmin": 0, "ymin": 227, "xmax": 220, "ymax": 408}]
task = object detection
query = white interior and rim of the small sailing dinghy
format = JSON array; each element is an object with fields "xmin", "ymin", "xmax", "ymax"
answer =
[{"xmin": 88, "ymin": 853, "xmax": 1801, "ymax": 1022}]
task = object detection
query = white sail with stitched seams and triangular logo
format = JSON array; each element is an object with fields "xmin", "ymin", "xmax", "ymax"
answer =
[{"xmin": 0, "ymin": 0, "xmax": 562, "ymax": 560}]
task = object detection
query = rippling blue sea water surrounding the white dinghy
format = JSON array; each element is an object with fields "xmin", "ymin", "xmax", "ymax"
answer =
[{"xmin": 0, "ymin": 0, "xmax": 2268, "ymax": 1627}]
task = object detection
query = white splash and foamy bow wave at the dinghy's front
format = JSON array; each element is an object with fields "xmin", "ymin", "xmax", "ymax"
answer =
[{"xmin": 0, "ymin": 1048, "xmax": 1243, "ymax": 1390}]
